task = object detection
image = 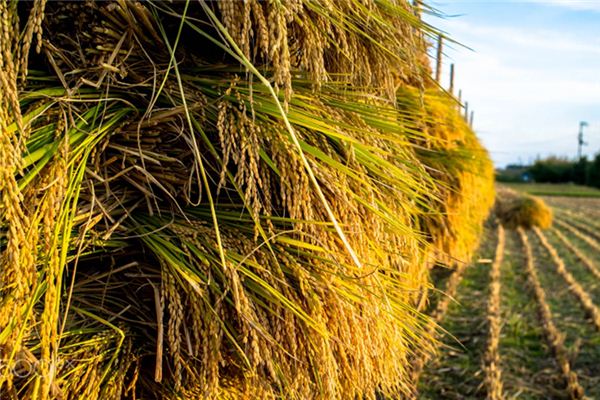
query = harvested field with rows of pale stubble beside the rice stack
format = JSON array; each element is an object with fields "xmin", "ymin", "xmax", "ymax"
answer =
[{"xmin": 419, "ymin": 195, "xmax": 600, "ymax": 399}]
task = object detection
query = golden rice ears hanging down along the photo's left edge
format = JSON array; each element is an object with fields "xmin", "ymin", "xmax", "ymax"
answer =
[{"xmin": 0, "ymin": 1, "xmax": 41, "ymax": 387}]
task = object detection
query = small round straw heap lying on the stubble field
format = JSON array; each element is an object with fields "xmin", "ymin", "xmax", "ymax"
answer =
[{"xmin": 494, "ymin": 188, "xmax": 552, "ymax": 229}]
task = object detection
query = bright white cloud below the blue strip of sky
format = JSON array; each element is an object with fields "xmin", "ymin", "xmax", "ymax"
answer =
[{"xmin": 428, "ymin": 15, "xmax": 600, "ymax": 165}]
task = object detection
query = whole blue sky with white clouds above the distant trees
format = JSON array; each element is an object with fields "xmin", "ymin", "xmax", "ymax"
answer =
[{"xmin": 426, "ymin": 0, "xmax": 600, "ymax": 166}]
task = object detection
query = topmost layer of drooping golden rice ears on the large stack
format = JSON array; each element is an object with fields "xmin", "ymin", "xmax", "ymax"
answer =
[{"xmin": 211, "ymin": 0, "xmax": 433, "ymax": 100}]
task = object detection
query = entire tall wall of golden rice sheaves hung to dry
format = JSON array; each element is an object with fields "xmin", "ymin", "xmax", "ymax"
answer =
[{"xmin": 0, "ymin": 0, "xmax": 493, "ymax": 399}]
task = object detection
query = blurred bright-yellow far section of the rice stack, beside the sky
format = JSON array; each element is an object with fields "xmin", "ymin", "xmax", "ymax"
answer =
[{"xmin": 398, "ymin": 88, "xmax": 494, "ymax": 266}]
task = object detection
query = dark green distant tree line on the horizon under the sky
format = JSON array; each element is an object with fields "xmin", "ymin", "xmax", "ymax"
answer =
[{"xmin": 496, "ymin": 153, "xmax": 600, "ymax": 188}]
